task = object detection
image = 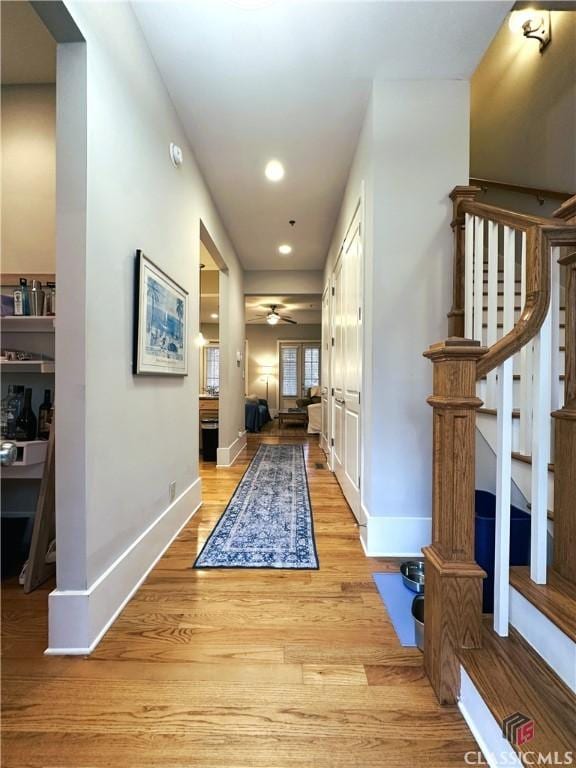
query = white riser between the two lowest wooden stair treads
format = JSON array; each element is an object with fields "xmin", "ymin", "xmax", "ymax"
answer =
[{"xmin": 510, "ymin": 587, "xmax": 576, "ymax": 693}]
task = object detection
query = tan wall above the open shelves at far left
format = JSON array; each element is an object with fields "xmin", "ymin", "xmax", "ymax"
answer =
[{"xmin": 2, "ymin": 85, "xmax": 56, "ymax": 275}]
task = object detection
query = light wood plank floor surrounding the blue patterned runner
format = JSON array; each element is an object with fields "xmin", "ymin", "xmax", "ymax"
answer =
[{"xmin": 2, "ymin": 427, "xmax": 477, "ymax": 768}]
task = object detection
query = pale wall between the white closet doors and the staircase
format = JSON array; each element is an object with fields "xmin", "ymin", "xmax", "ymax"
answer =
[{"xmin": 326, "ymin": 80, "xmax": 469, "ymax": 554}]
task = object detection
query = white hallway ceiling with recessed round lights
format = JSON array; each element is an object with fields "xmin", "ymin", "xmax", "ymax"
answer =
[{"xmin": 133, "ymin": 0, "xmax": 511, "ymax": 269}]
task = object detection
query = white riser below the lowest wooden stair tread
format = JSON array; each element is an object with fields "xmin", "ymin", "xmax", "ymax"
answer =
[{"xmin": 458, "ymin": 667, "xmax": 522, "ymax": 768}]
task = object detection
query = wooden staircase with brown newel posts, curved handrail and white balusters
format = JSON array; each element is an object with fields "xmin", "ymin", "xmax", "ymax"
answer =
[{"xmin": 424, "ymin": 187, "xmax": 576, "ymax": 767}]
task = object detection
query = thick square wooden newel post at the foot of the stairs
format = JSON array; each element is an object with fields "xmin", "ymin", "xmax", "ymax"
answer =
[{"xmin": 423, "ymin": 338, "xmax": 487, "ymax": 704}]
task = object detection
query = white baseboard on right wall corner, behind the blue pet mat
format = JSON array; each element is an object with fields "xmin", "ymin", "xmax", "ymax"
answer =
[{"xmin": 360, "ymin": 506, "xmax": 432, "ymax": 558}]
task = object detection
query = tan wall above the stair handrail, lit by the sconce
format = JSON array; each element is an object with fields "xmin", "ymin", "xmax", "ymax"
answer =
[{"xmin": 471, "ymin": 11, "xmax": 576, "ymax": 192}]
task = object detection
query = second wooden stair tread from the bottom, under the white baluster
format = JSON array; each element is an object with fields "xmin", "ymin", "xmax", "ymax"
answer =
[{"xmin": 510, "ymin": 565, "xmax": 576, "ymax": 640}]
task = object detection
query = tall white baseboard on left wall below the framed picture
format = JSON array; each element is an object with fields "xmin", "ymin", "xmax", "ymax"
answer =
[{"xmin": 45, "ymin": 478, "xmax": 202, "ymax": 656}]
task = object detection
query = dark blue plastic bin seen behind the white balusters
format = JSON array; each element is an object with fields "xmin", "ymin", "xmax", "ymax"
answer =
[{"xmin": 474, "ymin": 491, "xmax": 530, "ymax": 613}]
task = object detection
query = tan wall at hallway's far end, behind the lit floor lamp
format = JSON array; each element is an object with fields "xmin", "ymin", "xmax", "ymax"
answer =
[{"xmin": 246, "ymin": 324, "xmax": 322, "ymax": 410}]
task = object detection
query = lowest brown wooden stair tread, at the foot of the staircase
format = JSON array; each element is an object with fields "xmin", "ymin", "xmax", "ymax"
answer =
[{"xmin": 460, "ymin": 624, "xmax": 576, "ymax": 764}]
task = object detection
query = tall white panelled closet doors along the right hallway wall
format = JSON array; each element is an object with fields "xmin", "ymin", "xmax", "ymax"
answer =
[{"xmin": 332, "ymin": 207, "xmax": 362, "ymax": 519}]
